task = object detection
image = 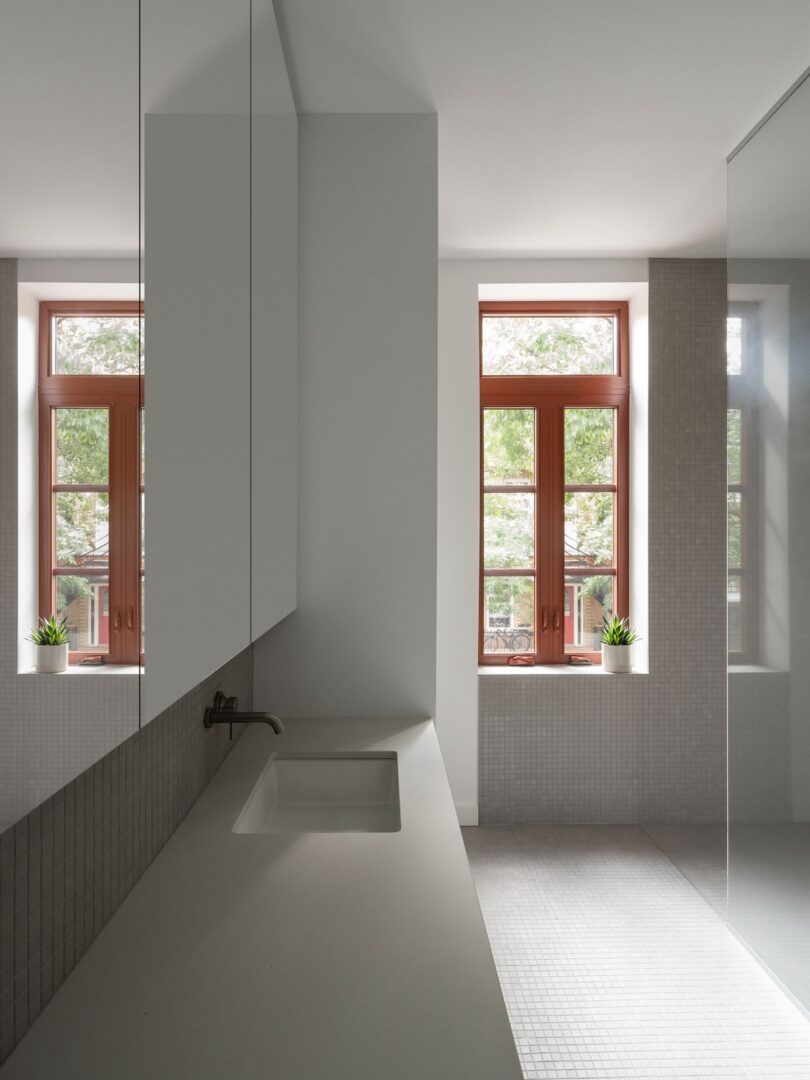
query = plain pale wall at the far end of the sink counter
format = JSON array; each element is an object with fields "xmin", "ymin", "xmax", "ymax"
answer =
[{"xmin": 254, "ymin": 114, "xmax": 437, "ymax": 716}]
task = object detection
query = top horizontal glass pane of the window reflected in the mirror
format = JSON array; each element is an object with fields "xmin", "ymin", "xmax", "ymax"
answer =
[{"xmin": 53, "ymin": 315, "xmax": 144, "ymax": 375}]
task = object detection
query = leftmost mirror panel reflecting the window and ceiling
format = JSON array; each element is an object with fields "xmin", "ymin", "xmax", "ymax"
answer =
[{"xmin": 0, "ymin": 0, "xmax": 143, "ymax": 831}]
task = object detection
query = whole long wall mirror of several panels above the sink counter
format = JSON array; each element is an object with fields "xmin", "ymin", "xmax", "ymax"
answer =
[{"xmin": 0, "ymin": 0, "xmax": 297, "ymax": 828}]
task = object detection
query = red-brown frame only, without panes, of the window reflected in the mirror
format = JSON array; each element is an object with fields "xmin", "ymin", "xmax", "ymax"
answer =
[{"xmin": 38, "ymin": 300, "xmax": 144, "ymax": 664}]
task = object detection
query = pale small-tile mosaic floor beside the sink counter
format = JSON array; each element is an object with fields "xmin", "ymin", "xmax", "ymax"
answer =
[{"xmin": 464, "ymin": 825, "xmax": 810, "ymax": 1080}]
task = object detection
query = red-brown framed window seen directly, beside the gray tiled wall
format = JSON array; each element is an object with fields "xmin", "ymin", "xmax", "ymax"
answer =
[{"xmin": 478, "ymin": 301, "xmax": 630, "ymax": 664}]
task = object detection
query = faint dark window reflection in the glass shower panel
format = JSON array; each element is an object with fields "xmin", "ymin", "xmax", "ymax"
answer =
[{"xmin": 726, "ymin": 302, "xmax": 760, "ymax": 664}]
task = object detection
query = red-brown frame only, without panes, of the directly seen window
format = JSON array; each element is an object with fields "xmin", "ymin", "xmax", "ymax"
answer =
[{"xmin": 478, "ymin": 300, "xmax": 630, "ymax": 665}]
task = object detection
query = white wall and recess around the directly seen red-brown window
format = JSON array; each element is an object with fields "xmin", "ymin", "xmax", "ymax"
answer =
[{"xmin": 436, "ymin": 259, "xmax": 647, "ymax": 824}]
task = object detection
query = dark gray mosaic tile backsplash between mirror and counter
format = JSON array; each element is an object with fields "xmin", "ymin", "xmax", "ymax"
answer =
[{"xmin": 0, "ymin": 649, "xmax": 253, "ymax": 1062}]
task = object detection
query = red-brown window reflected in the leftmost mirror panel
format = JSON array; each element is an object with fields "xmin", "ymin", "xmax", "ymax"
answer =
[{"xmin": 39, "ymin": 300, "xmax": 144, "ymax": 664}]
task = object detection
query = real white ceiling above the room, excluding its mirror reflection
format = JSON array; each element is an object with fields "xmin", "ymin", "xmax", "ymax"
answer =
[{"xmin": 275, "ymin": 0, "xmax": 810, "ymax": 256}]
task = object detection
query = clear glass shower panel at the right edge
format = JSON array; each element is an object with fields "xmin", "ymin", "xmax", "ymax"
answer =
[{"xmin": 727, "ymin": 69, "xmax": 810, "ymax": 1008}]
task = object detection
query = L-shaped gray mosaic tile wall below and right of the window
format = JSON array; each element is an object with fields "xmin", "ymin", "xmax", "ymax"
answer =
[{"xmin": 478, "ymin": 259, "xmax": 727, "ymax": 824}]
